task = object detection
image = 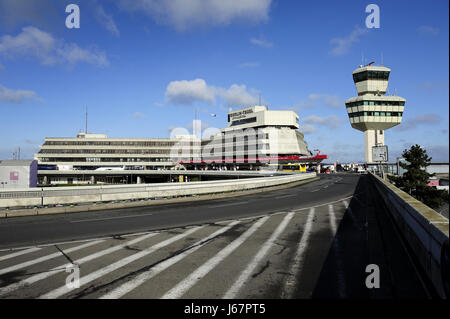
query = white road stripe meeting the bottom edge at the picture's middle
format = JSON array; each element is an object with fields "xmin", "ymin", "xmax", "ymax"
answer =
[{"xmin": 223, "ymin": 212, "xmax": 294, "ymax": 299}]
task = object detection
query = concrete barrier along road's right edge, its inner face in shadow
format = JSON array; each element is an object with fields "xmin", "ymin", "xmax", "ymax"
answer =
[{"xmin": 370, "ymin": 174, "xmax": 449, "ymax": 298}]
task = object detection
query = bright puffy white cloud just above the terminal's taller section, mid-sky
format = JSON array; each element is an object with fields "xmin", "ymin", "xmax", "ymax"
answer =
[{"xmin": 165, "ymin": 79, "xmax": 258, "ymax": 106}]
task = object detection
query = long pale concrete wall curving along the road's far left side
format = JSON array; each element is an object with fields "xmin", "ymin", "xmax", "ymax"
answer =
[{"xmin": 0, "ymin": 173, "xmax": 316, "ymax": 207}]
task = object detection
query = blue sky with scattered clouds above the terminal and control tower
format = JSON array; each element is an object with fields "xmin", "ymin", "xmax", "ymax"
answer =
[{"xmin": 0, "ymin": 0, "xmax": 449, "ymax": 162}]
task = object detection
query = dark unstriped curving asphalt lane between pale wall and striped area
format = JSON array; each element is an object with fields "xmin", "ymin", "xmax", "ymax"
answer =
[{"xmin": 0, "ymin": 175, "xmax": 359, "ymax": 249}]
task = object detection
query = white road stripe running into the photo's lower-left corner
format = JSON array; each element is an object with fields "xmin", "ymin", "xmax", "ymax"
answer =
[{"xmin": 0, "ymin": 233, "xmax": 156, "ymax": 296}]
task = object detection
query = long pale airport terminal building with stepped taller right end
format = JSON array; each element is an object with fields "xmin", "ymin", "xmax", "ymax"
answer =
[{"xmin": 35, "ymin": 106, "xmax": 326, "ymax": 184}]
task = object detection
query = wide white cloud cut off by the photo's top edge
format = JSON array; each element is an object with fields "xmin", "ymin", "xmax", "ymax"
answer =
[{"xmin": 119, "ymin": 0, "xmax": 272, "ymax": 31}]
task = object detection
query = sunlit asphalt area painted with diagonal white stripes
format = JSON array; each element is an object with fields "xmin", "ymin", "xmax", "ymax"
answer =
[{"xmin": 0, "ymin": 198, "xmax": 350, "ymax": 299}]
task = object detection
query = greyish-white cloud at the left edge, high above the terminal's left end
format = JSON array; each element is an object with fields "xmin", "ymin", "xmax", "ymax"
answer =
[{"xmin": 0, "ymin": 26, "xmax": 109, "ymax": 66}]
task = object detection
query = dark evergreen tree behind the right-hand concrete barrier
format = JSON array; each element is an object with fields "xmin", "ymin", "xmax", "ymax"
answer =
[{"xmin": 390, "ymin": 144, "xmax": 448, "ymax": 208}]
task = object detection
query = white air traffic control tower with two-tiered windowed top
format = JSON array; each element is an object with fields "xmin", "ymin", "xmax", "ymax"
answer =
[{"xmin": 345, "ymin": 62, "xmax": 406, "ymax": 163}]
